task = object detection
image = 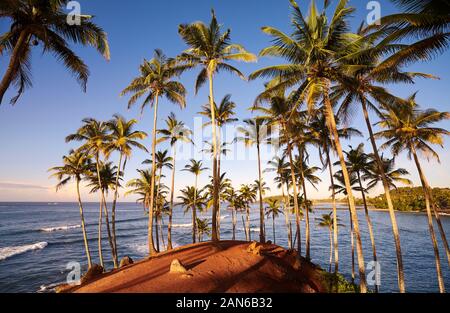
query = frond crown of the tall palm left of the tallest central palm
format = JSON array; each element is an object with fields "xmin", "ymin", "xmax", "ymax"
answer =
[{"xmin": 121, "ymin": 49, "xmax": 187, "ymax": 110}]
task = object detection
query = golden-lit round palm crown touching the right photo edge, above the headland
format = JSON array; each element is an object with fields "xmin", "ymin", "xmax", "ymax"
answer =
[{"xmin": 375, "ymin": 94, "xmax": 450, "ymax": 161}]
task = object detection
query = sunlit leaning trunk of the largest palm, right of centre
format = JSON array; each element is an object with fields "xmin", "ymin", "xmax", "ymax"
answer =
[{"xmin": 324, "ymin": 88, "xmax": 367, "ymax": 293}]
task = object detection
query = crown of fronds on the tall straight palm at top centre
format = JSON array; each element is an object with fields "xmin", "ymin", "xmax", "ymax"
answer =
[{"xmin": 178, "ymin": 10, "xmax": 257, "ymax": 93}]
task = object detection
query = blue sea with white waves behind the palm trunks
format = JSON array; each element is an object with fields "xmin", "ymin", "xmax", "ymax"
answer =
[{"xmin": 0, "ymin": 202, "xmax": 450, "ymax": 293}]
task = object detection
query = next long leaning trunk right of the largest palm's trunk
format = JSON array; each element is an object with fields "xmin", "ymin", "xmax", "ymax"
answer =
[{"xmin": 361, "ymin": 97, "xmax": 406, "ymax": 293}]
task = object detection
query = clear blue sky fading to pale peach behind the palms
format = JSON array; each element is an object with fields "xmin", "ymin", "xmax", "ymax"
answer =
[{"xmin": 0, "ymin": 0, "xmax": 450, "ymax": 202}]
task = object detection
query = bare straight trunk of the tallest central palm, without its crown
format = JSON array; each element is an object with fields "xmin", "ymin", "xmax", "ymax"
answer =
[{"xmin": 208, "ymin": 69, "xmax": 219, "ymax": 241}]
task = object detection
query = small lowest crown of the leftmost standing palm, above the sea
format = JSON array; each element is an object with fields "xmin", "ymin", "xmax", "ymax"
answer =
[{"xmin": 49, "ymin": 150, "xmax": 93, "ymax": 190}]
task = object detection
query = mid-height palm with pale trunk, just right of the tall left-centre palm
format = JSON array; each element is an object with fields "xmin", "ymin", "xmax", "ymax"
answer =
[{"xmin": 157, "ymin": 112, "xmax": 194, "ymax": 250}]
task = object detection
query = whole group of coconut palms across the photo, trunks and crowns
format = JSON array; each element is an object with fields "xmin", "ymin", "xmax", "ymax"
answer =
[{"xmin": 0, "ymin": 0, "xmax": 450, "ymax": 292}]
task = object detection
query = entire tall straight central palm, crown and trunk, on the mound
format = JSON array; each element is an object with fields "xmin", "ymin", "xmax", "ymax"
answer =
[{"xmin": 178, "ymin": 11, "xmax": 256, "ymax": 241}]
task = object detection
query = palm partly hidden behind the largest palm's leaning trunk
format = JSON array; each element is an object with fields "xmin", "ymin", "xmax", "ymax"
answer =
[{"xmin": 309, "ymin": 114, "xmax": 362, "ymax": 274}]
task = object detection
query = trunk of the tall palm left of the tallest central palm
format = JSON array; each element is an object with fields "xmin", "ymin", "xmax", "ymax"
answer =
[{"xmin": 148, "ymin": 91, "xmax": 159, "ymax": 256}]
